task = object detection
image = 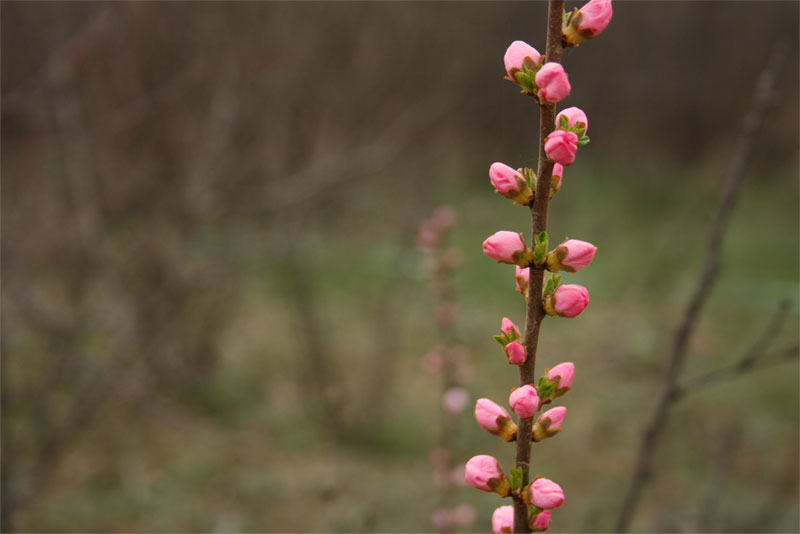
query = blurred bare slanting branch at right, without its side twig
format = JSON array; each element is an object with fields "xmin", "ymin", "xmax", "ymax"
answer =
[{"xmin": 616, "ymin": 47, "xmax": 785, "ymax": 532}]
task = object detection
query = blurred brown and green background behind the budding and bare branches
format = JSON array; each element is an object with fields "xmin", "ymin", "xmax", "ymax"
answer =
[{"xmin": 2, "ymin": 0, "xmax": 800, "ymax": 532}]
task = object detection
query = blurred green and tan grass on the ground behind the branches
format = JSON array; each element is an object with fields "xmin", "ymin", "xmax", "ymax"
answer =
[{"xmin": 14, "ymin": 153, "xmax": 800, "ymax": 532}]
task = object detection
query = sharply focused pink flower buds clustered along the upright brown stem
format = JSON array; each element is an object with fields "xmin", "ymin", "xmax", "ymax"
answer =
[{"xmin": 464, "ymin": 0, "xmax": 612, "ymax": 533}]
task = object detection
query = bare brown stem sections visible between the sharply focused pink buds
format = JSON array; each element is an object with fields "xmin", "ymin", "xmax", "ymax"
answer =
[{"xmin": 514, "ymin": 0, "xmax": 564, "ymax": 532}]
